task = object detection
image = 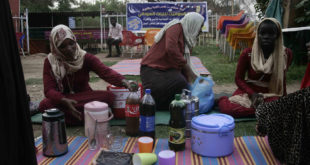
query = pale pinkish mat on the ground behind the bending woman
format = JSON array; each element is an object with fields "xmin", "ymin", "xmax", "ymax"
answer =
[{"xmin": 111, "ymin": 56, "xmax": 211, "ymax": 75}]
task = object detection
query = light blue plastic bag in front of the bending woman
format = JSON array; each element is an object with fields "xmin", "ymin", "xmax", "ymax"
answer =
[{"xmin": 190, "ymin": 77, "xmax": 214, "ymax": 114}]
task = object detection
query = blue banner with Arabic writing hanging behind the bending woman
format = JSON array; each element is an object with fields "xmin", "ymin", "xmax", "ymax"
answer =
[{"xmin": 126, "ymin": 2, "xmax": 209, "ymax": 32}]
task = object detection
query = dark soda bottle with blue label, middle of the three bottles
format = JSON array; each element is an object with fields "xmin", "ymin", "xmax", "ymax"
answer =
[{"xmin": 139, "ymin": 89, "xmax": 156, "ymax": 141}]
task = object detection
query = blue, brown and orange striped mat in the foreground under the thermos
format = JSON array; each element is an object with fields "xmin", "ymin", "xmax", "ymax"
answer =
[{"xmin": 35, "ymin": 136, "xmax": 280, "ymax": 165}]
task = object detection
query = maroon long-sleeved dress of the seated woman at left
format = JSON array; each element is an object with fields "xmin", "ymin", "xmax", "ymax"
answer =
[{"xmin": 39, "ymin": 54, "xmax": 124, "ymax": 125}]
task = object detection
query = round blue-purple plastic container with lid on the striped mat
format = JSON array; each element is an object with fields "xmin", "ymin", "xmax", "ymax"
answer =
[{"xmin": 191, "ymin": 114, "xmax": 235, "ymax": 157}]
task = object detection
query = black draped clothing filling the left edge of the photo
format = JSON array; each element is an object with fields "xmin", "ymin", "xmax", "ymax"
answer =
[{"xmin": 0, "ymin": 0, "xmax": 37, "ymax": 165}]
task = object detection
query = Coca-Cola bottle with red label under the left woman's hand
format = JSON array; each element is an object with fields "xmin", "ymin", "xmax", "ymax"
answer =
[{"xmin": 125, "ymin": 83, "xmax": 140, "ymax": 136}]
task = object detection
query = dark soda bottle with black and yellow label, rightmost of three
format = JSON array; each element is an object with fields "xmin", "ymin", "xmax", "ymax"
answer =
[{"xmin": 168, "ymin": 94, "xmax": 185, "ymax": 151}]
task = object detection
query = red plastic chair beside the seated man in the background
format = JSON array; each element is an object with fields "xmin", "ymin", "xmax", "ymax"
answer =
[{"xmin": 120, "ymin": 30, "xmax": 144, "ymax": 58}]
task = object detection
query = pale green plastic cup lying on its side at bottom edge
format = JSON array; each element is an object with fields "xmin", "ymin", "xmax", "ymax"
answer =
[{"xmin": 132, "ymin": 153, "xmax": 157, "ymax": 165}]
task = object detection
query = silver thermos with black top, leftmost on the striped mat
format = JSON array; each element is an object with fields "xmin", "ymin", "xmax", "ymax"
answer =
[{"xmin": 42, "ymin": 108, "xmax": 68, "ymax": 156}]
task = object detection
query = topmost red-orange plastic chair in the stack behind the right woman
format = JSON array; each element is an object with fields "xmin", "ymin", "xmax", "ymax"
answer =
[{"xmin": 217, "ymin": 10, "xmax": 244, "ymax": 50}]
